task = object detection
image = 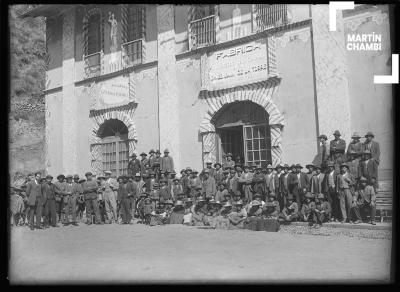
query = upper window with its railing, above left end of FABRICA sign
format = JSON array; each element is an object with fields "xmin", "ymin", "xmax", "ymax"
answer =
[{"xmin": 189, "ymin": 5, "xmax": 215, "ymax": 48}]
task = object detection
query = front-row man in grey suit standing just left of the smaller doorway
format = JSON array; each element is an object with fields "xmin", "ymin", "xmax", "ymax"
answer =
[{"xmin": 82, "ymin": 171, "xmax": 101, "ymax": 225}]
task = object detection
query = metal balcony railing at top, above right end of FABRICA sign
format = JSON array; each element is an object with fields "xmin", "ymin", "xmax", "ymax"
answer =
[{"xmin": 256, "ymin": 4, "xmax": 288, "ymax": 31}]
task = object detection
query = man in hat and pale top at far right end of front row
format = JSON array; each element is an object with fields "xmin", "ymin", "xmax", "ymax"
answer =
[{"xmin": 354, "ymin": 177, "xmax": 376, "ymax": 225}]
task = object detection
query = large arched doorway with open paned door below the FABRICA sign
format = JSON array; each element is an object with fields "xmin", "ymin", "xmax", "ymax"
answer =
[{"xmin": 211, "ymin": 101, "xmax": 272, "ymax": 167}]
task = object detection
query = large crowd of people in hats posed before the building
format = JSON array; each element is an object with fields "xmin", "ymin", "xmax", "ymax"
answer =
[{"xmin": 10, "ymin": 131, "xmax": 380, "ymax": 231}]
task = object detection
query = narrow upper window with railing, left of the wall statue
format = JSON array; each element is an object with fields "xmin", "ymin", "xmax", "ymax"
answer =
[{"xmin": 84, "ymin": 13, "xmax": 102, "ymax": 77}]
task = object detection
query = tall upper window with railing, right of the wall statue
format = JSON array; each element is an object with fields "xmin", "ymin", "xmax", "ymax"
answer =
[{"xmin": 122, "ymin": 5, "xmax": 146, "ymax": 66}]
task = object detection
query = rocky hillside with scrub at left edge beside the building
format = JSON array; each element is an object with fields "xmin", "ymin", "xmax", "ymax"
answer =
[{"xmin": 9, "ymin": 5, "xmax": 46, "ymax": 180}]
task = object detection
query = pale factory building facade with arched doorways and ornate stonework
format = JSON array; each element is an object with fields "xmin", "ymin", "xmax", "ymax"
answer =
[{"xmin": 26, "ymin": 4, "xmax": 393, "ymax": 189}]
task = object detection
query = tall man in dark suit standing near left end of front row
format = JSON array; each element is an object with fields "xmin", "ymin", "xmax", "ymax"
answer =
[{"xmin": 26, "ymin": 172, "xmax": 43, "ymax": 230}]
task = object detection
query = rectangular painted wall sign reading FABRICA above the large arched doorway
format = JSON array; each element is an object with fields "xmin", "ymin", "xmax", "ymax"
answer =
[{"xmin": 207, "ymin": 39, "xmax": 268, "ymax": 90}]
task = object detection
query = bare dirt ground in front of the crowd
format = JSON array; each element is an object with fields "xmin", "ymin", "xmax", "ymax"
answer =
[{"xmin": 9, "ymin": 224, "xmax": 391, "ymax": 284}]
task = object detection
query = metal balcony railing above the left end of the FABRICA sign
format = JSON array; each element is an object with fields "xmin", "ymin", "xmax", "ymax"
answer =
[{"xmin": 189, "ymin": 15, "xmax": 215, "ymax": 48}]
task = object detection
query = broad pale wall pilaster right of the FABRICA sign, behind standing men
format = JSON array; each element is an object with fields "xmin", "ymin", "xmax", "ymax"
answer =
[{"xmin": 311, "ymin": 5, "xmax": 351, "ymax": 141}]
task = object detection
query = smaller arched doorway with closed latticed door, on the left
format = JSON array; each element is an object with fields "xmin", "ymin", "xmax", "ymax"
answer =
[{"xmin": 97, "ymin": 119, "xmax": 129, "ymax": 176}]
